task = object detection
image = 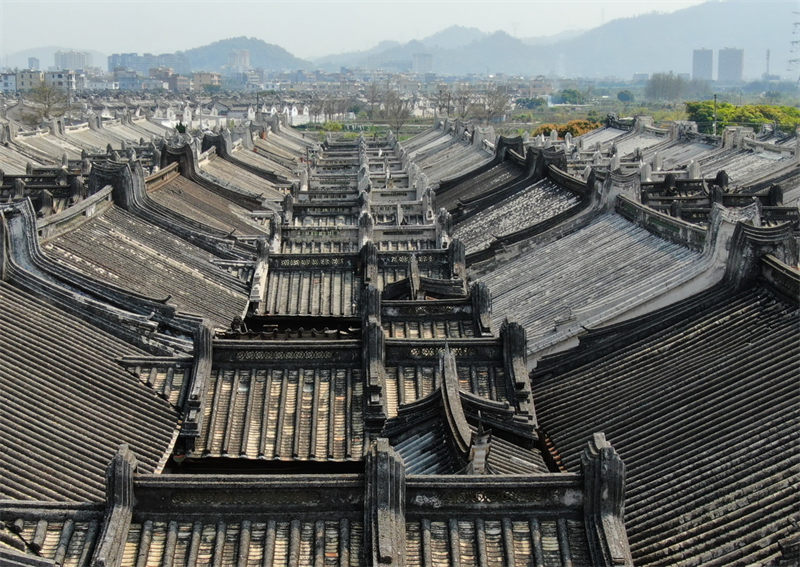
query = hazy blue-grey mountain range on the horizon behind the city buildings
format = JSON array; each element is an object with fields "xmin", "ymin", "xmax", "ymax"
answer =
[{"xmin": 4, "ymin": 0, "xmax": 798, "ymax": 78}]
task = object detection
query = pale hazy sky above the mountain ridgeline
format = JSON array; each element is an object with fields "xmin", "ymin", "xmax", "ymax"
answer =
[{"xmin": 0, "ymin": 0, "xmax": 703, "ymax": 58}]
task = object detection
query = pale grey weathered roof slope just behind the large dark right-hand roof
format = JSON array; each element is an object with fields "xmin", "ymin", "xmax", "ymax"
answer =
[{"xmin": 479, "ymin": 213, "xmax": 703, "ymax": 356}]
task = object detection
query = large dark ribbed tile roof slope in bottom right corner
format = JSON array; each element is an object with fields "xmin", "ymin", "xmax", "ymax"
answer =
[{"xmin": 533, "ymin": 286, "xmax": 800, "ymax": 566}]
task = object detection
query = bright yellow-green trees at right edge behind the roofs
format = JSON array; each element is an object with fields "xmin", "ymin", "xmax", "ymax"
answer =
[{"xmin": 686, "ymin": 100, "xmax": 800, "ymax": 133}]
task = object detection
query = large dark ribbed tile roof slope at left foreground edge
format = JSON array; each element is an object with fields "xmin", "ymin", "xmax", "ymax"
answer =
[{"xmin": 0, "ymin": 282, "xmax": 178, "ymax": 501}]
